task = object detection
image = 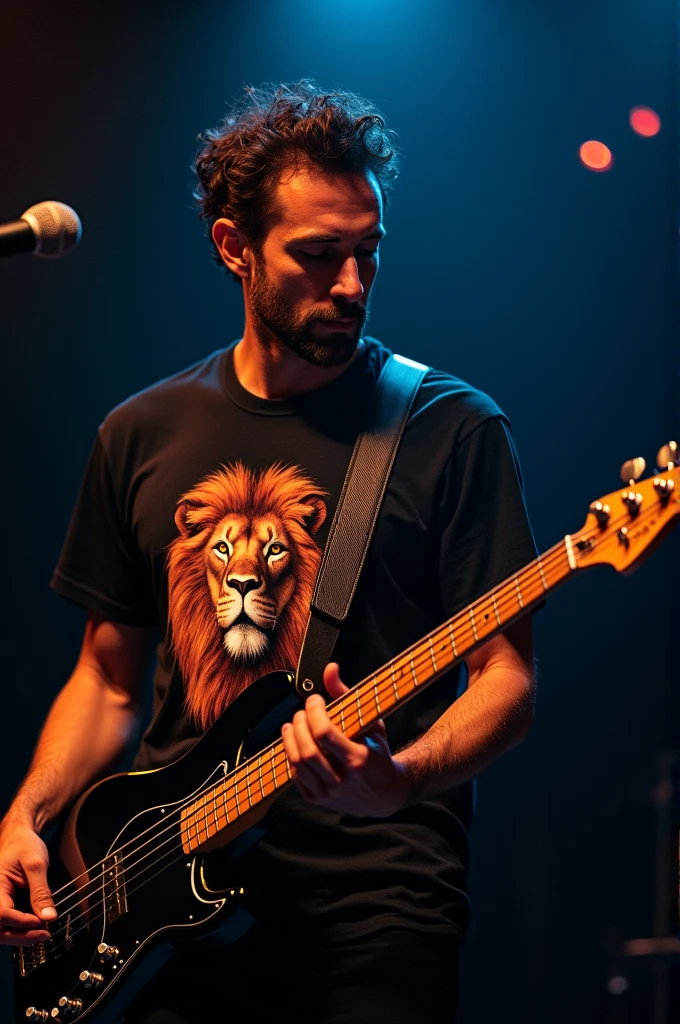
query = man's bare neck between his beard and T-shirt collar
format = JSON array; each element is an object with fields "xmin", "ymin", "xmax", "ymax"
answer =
[{"xmin": 233, "ymin": 322, "xmax": 364, "ymax": 400}]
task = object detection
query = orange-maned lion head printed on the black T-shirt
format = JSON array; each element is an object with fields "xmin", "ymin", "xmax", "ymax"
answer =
[{"xmin": 168, "ymin": 462, "xmax": 328, "ymax": 729}]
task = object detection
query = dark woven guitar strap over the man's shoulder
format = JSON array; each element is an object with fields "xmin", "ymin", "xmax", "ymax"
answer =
[{"xmin": 295, "ymin": 355, "xmax": 428, "ymax": 697}]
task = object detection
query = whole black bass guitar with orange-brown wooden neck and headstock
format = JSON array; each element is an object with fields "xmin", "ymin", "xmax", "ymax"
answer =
[{"xmin": 14, "ymin": 444, "xmax": 680, "ymax": 1024}]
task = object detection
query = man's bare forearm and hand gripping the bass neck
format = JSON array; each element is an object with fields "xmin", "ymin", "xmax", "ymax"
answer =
[{"xmin": 282, "ymin": 617, "xmax": 535, "ymax": 817}]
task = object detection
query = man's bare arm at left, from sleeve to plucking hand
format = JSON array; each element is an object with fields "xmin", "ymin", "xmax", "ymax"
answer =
[{"xmin": 0, "ymin": 615, "xmax": 155, "ymax": 944}]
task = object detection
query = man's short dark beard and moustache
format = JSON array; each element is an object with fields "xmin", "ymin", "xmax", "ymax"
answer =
[{"xmin": 250, "ymin": 252, "xmax": 370, "ymax": 368}]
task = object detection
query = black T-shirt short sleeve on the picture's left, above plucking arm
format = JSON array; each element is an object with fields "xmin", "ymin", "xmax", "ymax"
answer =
[{"xmin": 50, "ymin": 434, "xmax": 158, "ymax": 626}]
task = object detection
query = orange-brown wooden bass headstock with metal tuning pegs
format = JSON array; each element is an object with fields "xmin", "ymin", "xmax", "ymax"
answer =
[{"xmin": 567, "ymin": 441, "xmax": 680, "ymax": 572}]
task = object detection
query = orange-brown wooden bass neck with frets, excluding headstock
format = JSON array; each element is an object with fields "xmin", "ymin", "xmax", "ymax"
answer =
[{"xmin": 180, "ymin": 536, "xmax": 576, "ymax": 854}]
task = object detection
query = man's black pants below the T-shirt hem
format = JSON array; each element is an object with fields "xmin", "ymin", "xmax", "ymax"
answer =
[{"xmin": 125, "ymin": 928, "xmax": 458, "ymax": 1024}]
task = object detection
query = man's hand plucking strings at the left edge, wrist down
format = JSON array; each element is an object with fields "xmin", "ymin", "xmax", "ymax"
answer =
[{"xmin": 0, "ymin": 811, "xmax": 56, "ymax": 946}]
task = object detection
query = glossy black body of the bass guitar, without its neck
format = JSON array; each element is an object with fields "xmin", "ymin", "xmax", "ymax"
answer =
[{"xmin": 14, "ymin": 672, "xmax": 300, "ymax": 1024}]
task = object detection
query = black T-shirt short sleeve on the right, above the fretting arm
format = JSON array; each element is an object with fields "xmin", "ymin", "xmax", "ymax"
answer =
[{"xmin": 439, "ymin": 416, "xmax": 537, "ymax": 615}]
